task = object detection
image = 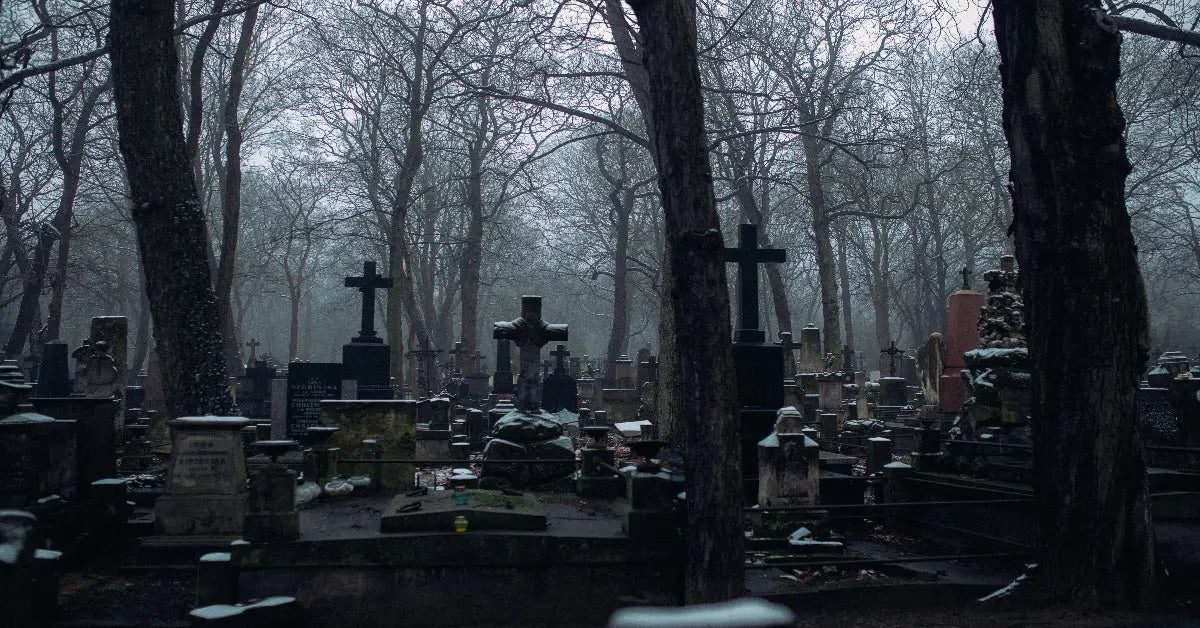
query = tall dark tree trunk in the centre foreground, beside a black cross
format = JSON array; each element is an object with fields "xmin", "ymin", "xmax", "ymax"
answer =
[{"xmin": 630, "ymin": 0, "xmax": 745, "ymax": 604}]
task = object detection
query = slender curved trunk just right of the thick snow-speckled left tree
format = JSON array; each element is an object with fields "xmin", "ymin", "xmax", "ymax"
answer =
[{"xmin": 216, "ymin": 5, "xmax": 258, "ymax": 375}]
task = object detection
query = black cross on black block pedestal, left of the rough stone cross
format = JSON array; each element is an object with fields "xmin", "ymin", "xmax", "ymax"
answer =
[{"xmin": 335, "ymin": 262, "xmax": 392, "ymax": 399}]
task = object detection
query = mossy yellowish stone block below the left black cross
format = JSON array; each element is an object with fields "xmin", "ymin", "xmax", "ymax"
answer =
[{"xmin": 320, "ymin": 400, "xmax": 416, "ymax": 492}]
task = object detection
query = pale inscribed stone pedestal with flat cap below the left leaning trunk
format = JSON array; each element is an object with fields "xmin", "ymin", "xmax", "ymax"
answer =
[{"xmin": 155, "ymin": 417, "xmax": 250, "ymax": 536}]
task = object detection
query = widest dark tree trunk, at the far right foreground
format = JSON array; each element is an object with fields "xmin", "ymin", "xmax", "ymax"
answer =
[{"xmin": 994, "ymin": 0, "xmax": 1156, "ymax": 609}]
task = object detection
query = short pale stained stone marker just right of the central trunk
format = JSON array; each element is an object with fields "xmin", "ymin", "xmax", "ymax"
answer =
[{"xmin": 758, "ymin": 432, "xmax": 821, "ymax": 508}]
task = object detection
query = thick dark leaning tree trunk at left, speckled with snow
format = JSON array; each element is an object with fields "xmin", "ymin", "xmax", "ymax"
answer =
[{"xmin": 109, "ymin": 0, "xmax": 233, "ymax": 417}]
